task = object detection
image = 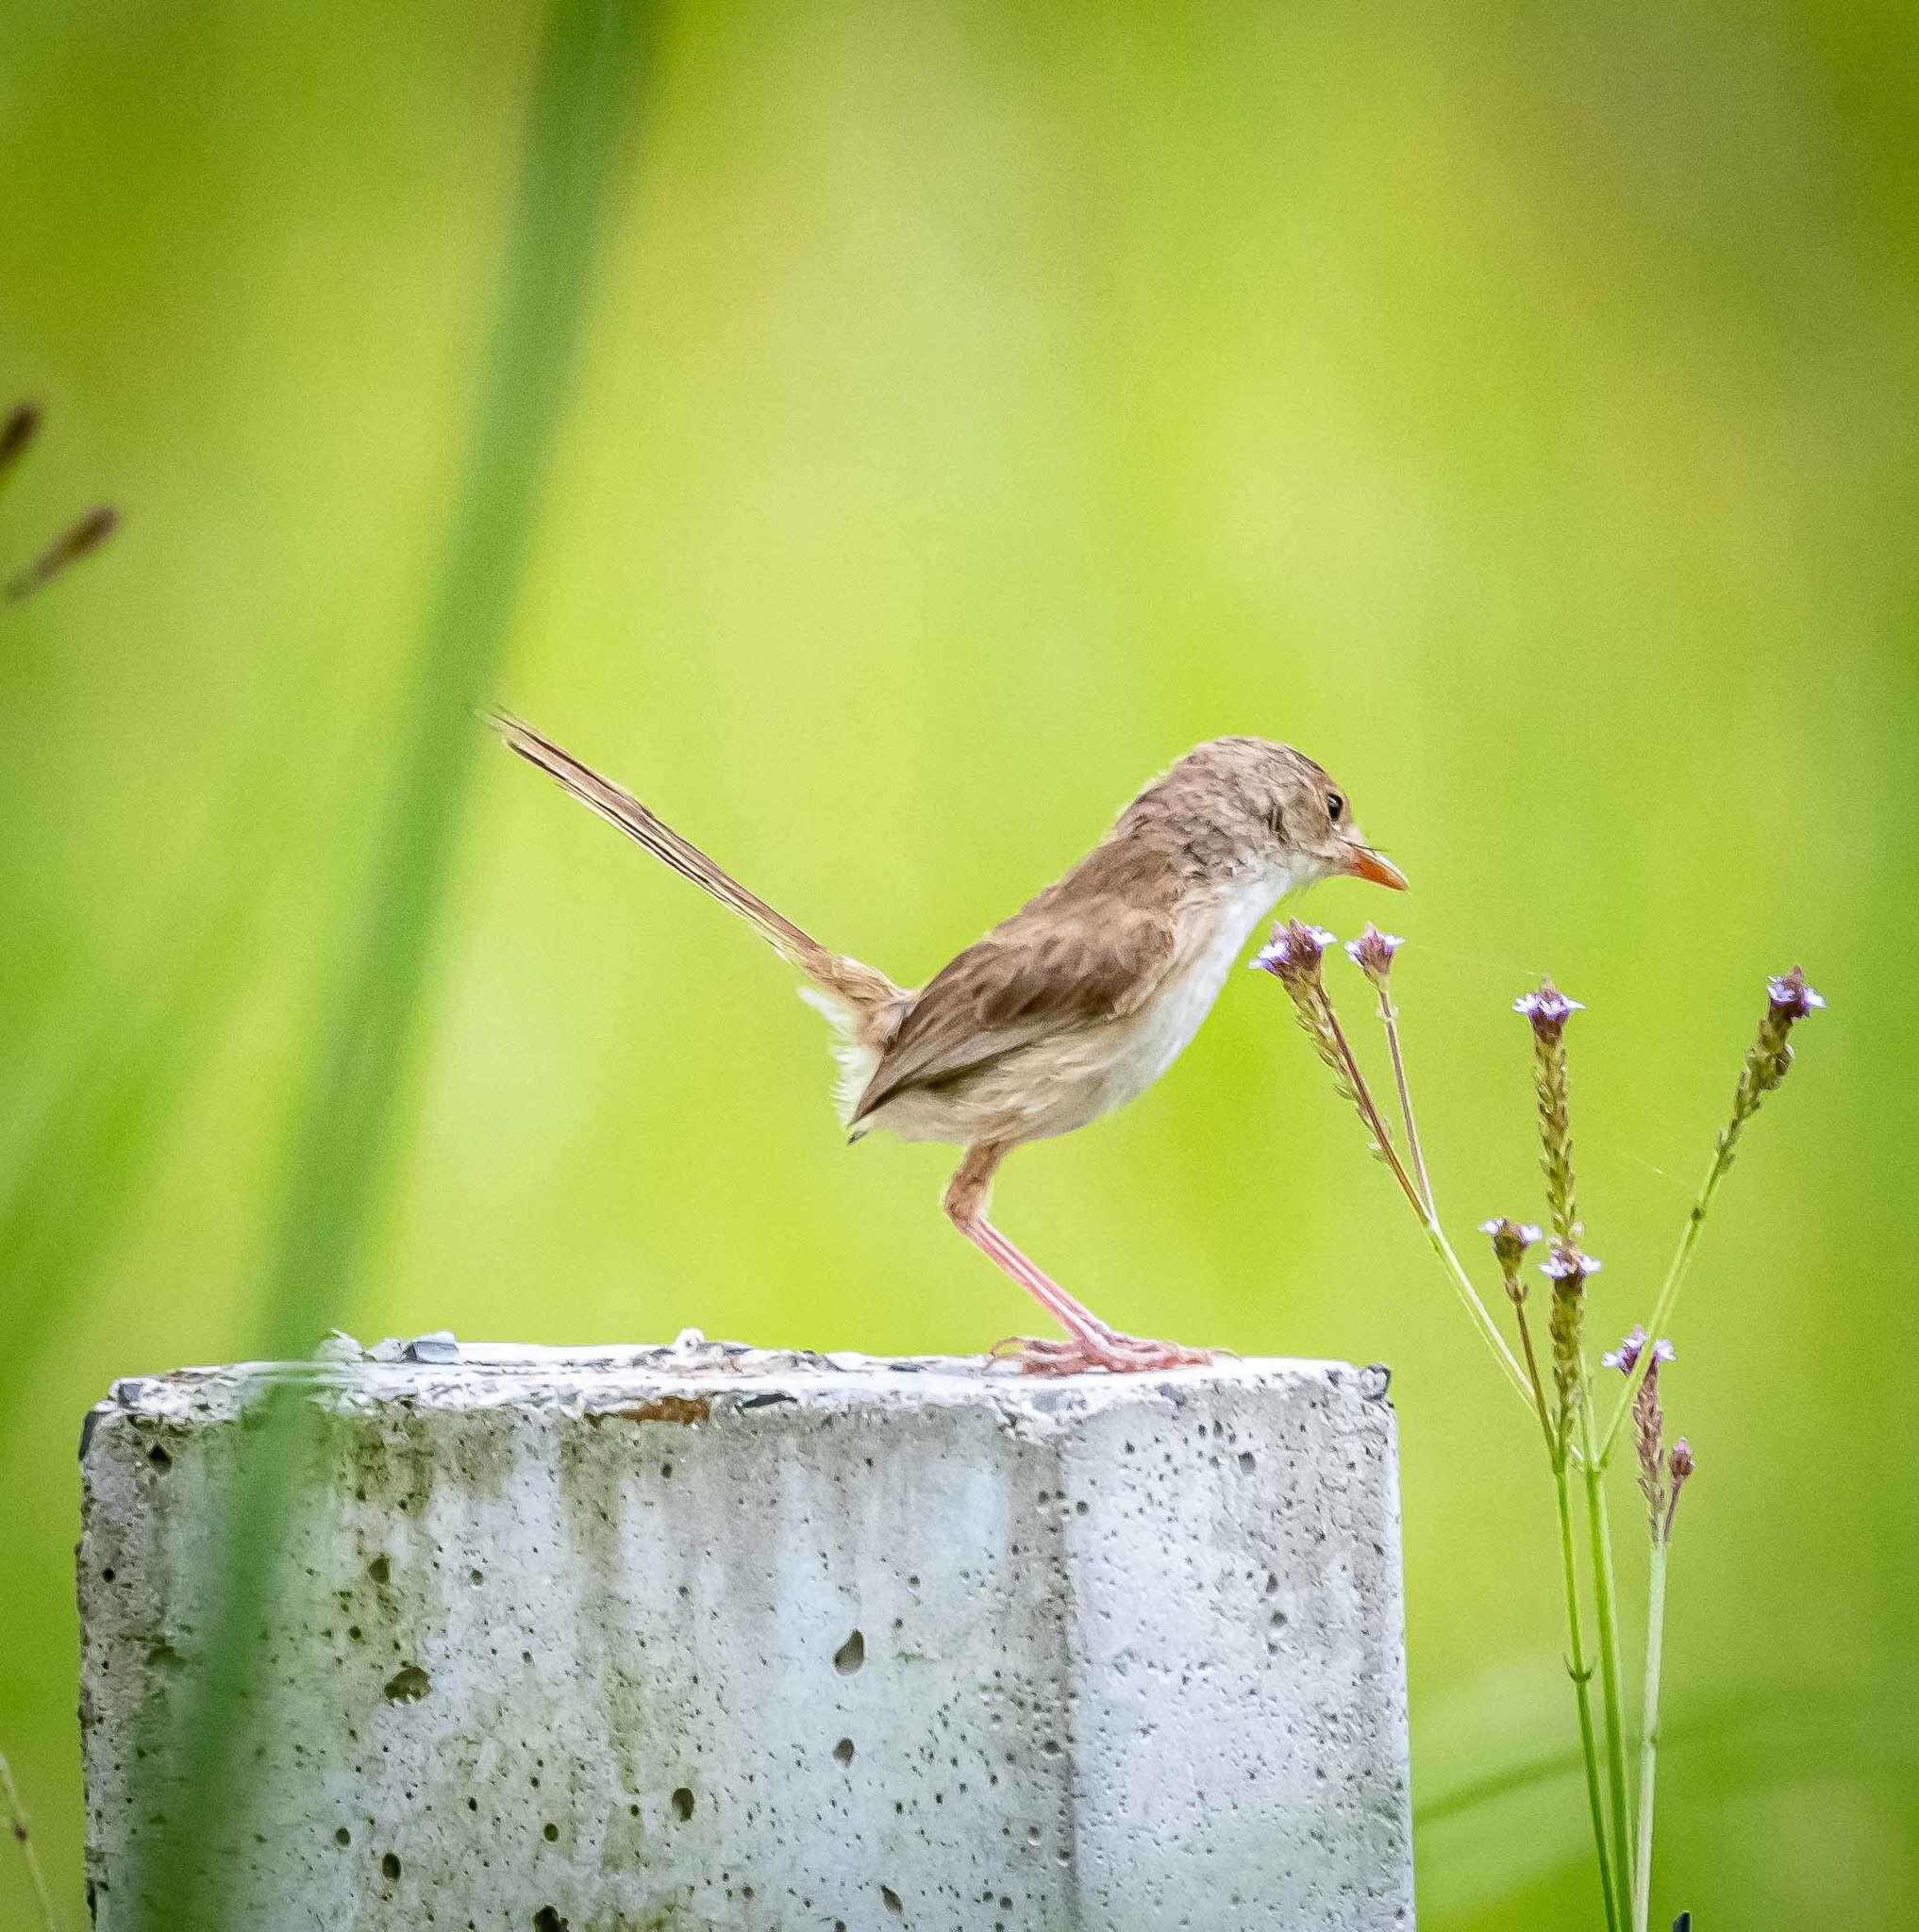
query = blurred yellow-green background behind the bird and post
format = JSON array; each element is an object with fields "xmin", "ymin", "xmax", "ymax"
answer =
[{"xmin": 0, "ymin": 0, "xmax": 1919, "ymax": 1932}]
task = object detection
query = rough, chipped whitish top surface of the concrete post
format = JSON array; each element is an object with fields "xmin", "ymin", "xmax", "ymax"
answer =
[{"xmin": 101, "ymin": 1329, "xmax": 1390, "ymax": 1422}]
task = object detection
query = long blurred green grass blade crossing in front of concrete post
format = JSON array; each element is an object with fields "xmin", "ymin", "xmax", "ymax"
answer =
[{"xmin": 135, "ymin": 0, "xmax": 651, "ymax": 1932}]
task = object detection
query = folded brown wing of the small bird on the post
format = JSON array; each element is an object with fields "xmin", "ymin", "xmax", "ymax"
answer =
[{"xmin": 848, "ymin": 900, "xmax": 1176, "ymax": 1124}]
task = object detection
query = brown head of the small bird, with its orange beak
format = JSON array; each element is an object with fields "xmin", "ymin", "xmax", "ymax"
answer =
[{"xmin": 1113, "ymin": 738, "xmax": 1407, "ymax": 892}]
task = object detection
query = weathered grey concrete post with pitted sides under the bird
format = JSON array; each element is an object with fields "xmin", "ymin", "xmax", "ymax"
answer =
[{"xmin": 79, "ymin": 1335, "xmax": 1412, "ymax": 1932}]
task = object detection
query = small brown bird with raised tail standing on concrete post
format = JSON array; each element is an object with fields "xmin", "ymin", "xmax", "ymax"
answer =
[{"xmin": 492, "ymin": 713, "xmax": 1405, "ymax": 1374}]
